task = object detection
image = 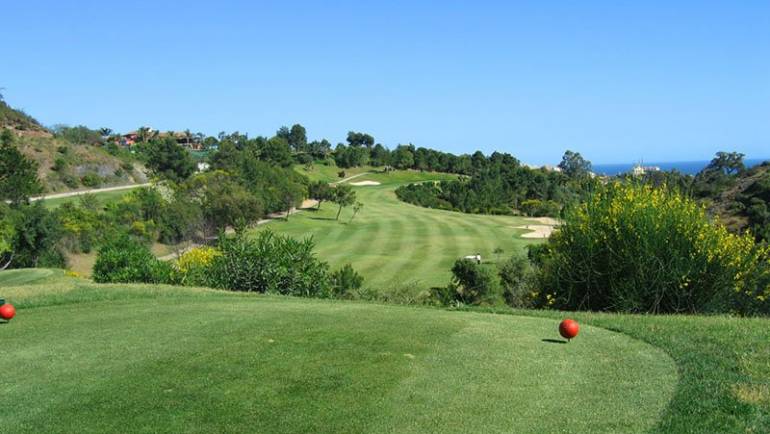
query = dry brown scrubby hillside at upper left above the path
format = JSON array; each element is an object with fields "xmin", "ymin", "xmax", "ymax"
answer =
[{"xmin": 0, "ymin": 100, "xmax": 147, "ymax": 193}]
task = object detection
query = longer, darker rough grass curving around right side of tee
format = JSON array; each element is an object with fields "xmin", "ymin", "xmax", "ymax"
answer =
[{"xmin": 468, "ymin": 309, "xmax": 770, "ymax": 433}]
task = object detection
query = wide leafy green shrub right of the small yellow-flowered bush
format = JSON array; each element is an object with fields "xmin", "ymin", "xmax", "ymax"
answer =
[{"xmin": 208, "ymin": 231, "xmax": 330, "ymax": 297}]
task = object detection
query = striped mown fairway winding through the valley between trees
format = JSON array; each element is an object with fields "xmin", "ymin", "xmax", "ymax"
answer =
[{"xmin": 255, "ymin": 171, "xmax": 537, "ymax": 293}]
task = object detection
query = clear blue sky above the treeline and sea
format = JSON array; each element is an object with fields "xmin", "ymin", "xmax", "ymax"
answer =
[{"xmin": 0, "ymin": 1, "xmax": 770, "ymax": 164}]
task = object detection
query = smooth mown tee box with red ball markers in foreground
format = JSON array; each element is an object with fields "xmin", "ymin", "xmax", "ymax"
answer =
[{"xmin": 0, "ymin": 290, "xmax": 677, "ymax": 433}]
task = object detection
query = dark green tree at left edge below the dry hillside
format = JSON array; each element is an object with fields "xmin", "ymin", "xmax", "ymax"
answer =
[{"xmin": 0, "ymin": 129, "xmax": 43, "ymax": 205}]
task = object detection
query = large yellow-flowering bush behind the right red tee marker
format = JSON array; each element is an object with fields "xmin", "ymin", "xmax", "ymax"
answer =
[{"xmin": 540, "ymin": 183, "xmax": 770, "ymax": 313}]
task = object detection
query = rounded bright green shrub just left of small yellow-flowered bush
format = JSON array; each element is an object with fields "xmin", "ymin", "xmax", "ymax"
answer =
[{"xmin": 93, "ymin": 235, "xmax": 173, "ymax": 283}]
